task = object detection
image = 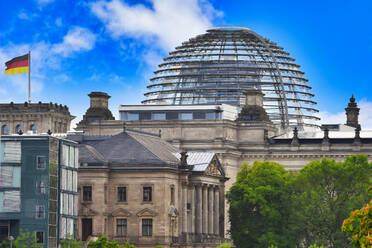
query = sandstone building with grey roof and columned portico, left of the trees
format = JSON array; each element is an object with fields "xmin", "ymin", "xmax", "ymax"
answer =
[{"xmin": 69, "ymin": 130, "xmax": 227, "ymax": 248}]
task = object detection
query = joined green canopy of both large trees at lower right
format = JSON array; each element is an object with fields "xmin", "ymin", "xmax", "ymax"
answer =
[{"xmin": 227, "ymin": 155, "xmax": 372, "ymax": 248}]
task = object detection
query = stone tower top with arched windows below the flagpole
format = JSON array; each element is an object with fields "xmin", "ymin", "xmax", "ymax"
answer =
[{"xmin": 0, "ymin": 102, "xmax": 75, "ymax": 134}]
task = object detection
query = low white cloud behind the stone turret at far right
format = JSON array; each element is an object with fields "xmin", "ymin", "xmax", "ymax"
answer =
[{"xmin": 319, "ymin": 99, "xmax": 372, "ymax": 129}]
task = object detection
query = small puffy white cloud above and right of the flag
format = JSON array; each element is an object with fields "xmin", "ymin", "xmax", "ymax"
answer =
[{"xmin": 53, "ymin": 27, "xmax": 96, "ymax": 57}]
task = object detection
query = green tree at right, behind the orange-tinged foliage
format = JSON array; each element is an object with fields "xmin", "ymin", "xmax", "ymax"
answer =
[{"xmin": 292, "ymin": 155, "xmax": 372, "ymax": 248}]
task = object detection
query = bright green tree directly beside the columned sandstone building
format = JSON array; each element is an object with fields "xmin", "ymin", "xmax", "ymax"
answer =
[{"xmin": 227, "ymin": 161, "xmax": 295, "ymax": 248}]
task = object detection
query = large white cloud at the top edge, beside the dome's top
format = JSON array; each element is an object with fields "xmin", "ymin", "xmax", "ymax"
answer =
[{"xmin": 90, "ymin": 0, "xmax": 223, "ymax": 51}]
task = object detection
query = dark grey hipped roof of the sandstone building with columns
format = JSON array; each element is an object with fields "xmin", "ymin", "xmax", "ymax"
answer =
[{"xmin": 79, "ymin": 131, "xmax": 179, "ymax": 165}]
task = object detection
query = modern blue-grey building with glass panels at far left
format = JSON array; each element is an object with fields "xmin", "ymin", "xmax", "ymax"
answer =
[{"xmin": 0, "ymin": 135, "xmax": 78, "ymax": 248}]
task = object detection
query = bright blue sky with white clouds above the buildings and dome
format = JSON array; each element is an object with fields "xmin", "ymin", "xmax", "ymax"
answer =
[{"xmin": 0, "ymin": 0, "xmax": 372, "ymax": 128}]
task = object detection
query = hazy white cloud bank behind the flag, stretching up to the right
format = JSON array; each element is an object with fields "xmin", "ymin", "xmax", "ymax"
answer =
[{"xmin": 0, "ymin": 27, "xmax": 95, "ymax": 101}]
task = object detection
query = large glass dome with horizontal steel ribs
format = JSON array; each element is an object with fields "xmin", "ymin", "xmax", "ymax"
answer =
[{"xmin": 142, "ymin": 27, "xmax": 319, "ymax": 129}]
